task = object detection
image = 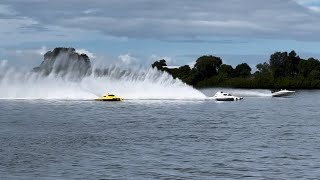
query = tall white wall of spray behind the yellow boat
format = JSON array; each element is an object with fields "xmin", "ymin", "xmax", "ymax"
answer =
[{"xmin": 0, "ymin": 61, "xmax": 206, "ymax": 100}]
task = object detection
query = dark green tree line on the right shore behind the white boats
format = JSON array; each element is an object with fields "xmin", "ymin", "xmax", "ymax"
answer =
[{"xmin": 152, "ymin": 51, "xmax": 320, "ymax": 89}]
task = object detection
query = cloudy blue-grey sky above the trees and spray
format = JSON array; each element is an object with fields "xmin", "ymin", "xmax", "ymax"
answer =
[{"xmin": 0, "ymin": 0, "xmax": 320, "ymax": 66}]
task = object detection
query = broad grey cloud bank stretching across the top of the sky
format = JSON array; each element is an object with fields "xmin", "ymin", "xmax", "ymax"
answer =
[{"xmin": 2, "ymin": 0, "xmax": 320, "ymax": 41}]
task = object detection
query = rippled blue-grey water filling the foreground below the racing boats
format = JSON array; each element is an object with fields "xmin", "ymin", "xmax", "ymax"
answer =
[{"xmin": 0, "ymin": 91, "xmax": 320, "ymax": 179}]
